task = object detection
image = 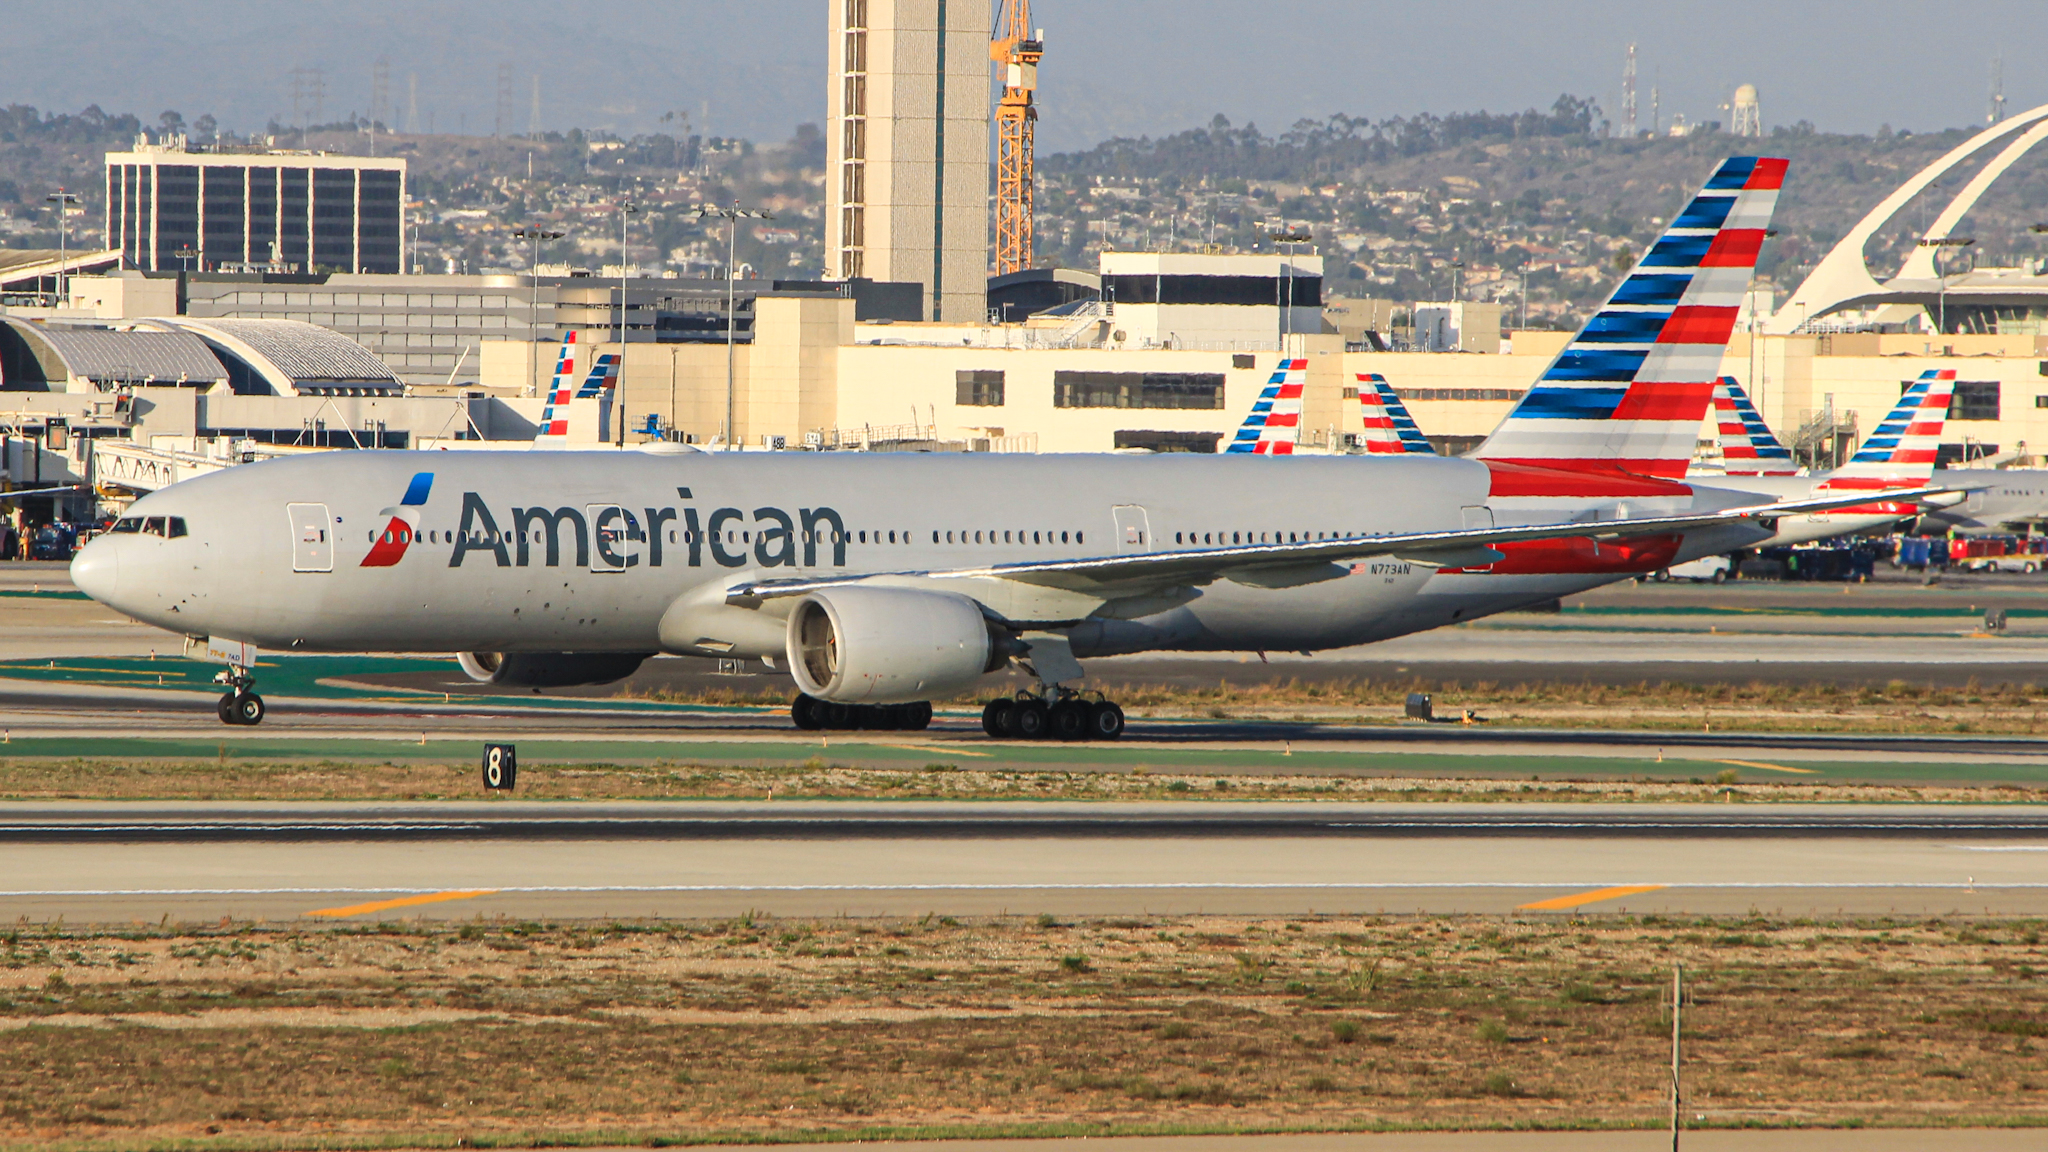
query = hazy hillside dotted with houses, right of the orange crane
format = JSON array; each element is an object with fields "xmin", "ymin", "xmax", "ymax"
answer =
[{"xmin": 1040, "ymin": 96, "xmax": 2048, "ymax": 320}]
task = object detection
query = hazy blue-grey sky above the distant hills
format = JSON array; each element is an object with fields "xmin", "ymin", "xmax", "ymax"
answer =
[{"xmin": 0, "ymin": 0, "xmax": 2048, "ymax": 152}]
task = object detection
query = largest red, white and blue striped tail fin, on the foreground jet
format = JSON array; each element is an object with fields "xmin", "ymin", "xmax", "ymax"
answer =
[{"xmin": 1473, "ymin": 156, "xmax": 1786, "ymax": 480}]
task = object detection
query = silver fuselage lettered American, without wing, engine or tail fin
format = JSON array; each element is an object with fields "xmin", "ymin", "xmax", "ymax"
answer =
[{"xmin": 74, "ymin": 451, "xmax": 1765, "ymax": 656}]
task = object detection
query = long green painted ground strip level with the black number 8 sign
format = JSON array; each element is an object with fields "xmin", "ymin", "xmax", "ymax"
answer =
[{"xmin": 0, "ymin": 734, "xmax": 2048, "ymax": 785}]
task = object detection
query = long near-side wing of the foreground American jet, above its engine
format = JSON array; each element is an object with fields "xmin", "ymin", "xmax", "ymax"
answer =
[{"xmin": 725, "ymin": 479, "xmax": 1954, "ymax": 607}]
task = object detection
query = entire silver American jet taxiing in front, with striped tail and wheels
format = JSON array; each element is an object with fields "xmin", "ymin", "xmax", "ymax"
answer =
[{"xmin": 72, "ymin": 158, "xmax": 1949, "ymax": 738}]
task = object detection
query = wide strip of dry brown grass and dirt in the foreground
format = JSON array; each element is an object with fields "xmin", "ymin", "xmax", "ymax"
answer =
[{"xmin": 0, "ymin": 916, "xmax": 2048, "ymax": 1148}]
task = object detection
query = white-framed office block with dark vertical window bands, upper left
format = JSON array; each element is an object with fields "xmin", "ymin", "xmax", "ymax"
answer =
[{"xmin": 106, "ymin": 137, "xmax": 406, "ymax": 273}]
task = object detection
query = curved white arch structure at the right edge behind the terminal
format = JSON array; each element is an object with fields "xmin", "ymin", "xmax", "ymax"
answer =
[{"xmin": 1763, "ymin": 105, "xmax": 2048, "ymax": 336}]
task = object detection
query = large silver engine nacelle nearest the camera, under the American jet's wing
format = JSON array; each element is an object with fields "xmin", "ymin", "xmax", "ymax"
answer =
[{"xmin": 786, "ymin": 584, "xmax": 1010, "ymax": 703}]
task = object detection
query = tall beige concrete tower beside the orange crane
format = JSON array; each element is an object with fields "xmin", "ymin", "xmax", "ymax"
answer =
[{"xmin": 825, "ymin": 0, "xmax": 989, "ymax": 322}]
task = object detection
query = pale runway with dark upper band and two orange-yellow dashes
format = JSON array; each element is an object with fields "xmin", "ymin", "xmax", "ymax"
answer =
[{"xmin": 0, "ymin": 801, "xmax": 2048, "ymax": 922}]
